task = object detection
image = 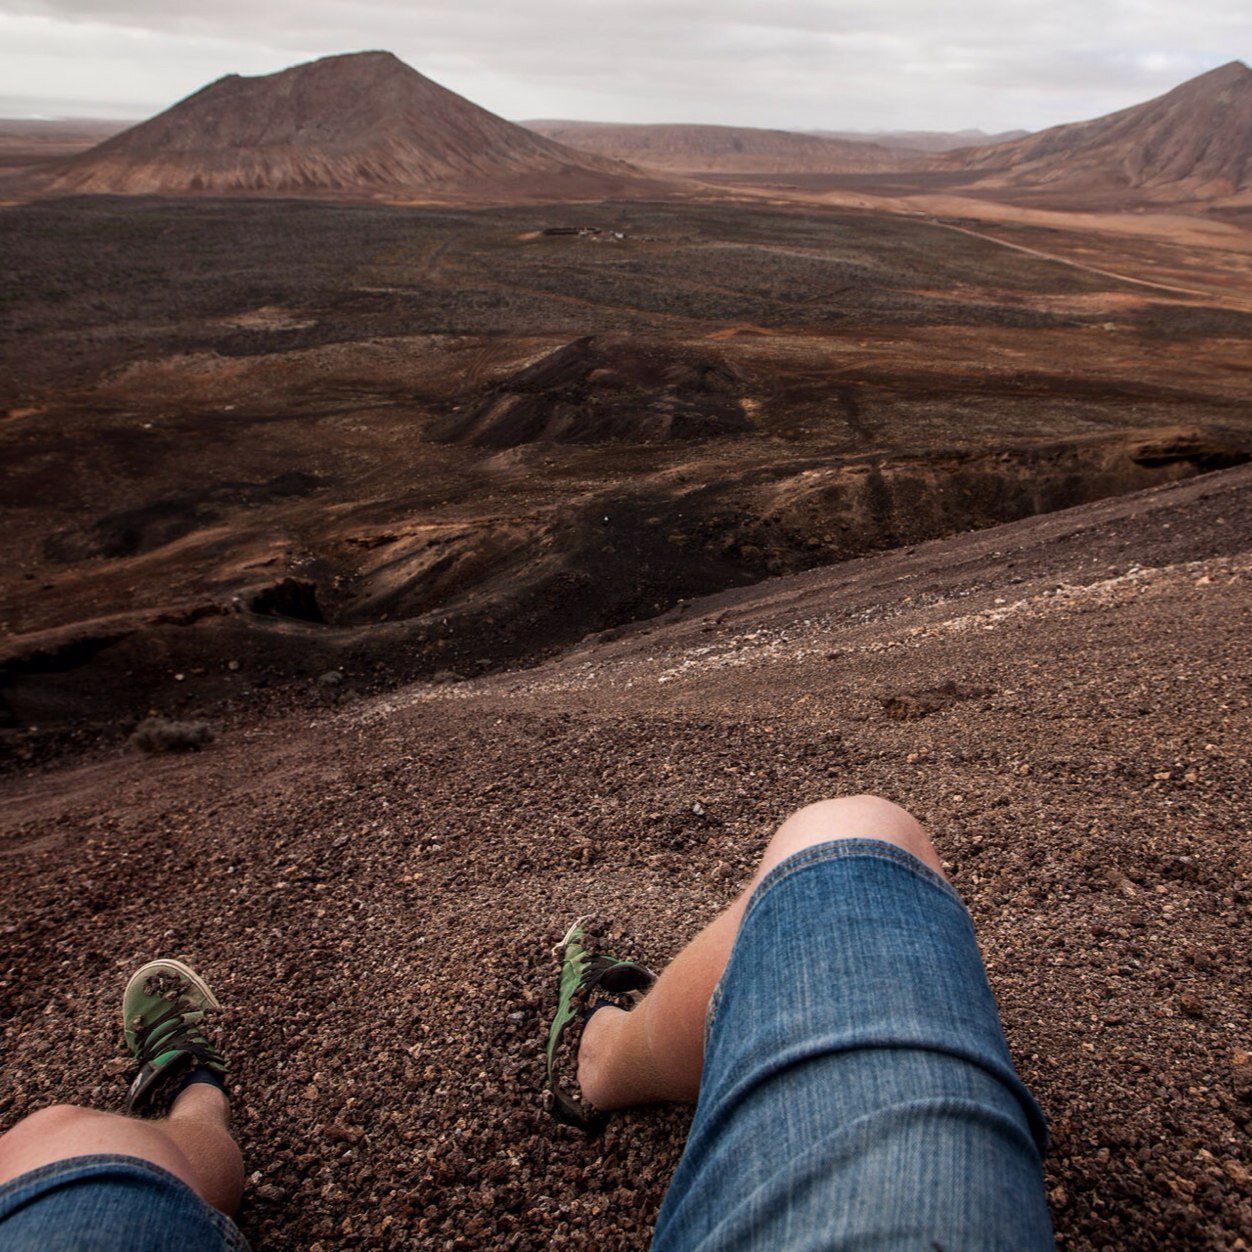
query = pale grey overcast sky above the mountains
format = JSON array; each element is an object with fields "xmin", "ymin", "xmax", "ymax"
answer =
[{"xmin": 0, "ymin": 0, "xmax": 1252, "ymax": 131}]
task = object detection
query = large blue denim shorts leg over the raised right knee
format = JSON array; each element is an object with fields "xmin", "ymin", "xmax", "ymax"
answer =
[{"xmin": 652, "ymin": 839, "xmax": 1053, "ymax": 1252}]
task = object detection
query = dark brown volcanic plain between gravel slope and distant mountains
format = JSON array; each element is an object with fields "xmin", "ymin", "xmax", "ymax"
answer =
[{"xmin": 0, "ymin": 198, "xmax": 1252, "ymax": 764}]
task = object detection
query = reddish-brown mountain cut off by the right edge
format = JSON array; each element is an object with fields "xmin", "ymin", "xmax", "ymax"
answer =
[{"xmin": 950, "ymin": 61, "xmax": 1252, "ymax": 200}]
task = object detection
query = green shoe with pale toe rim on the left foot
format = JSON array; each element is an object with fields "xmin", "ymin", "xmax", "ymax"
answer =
[{"xmin": 121, "ymin": 959, "xmax": 227, "ymax": 1113}]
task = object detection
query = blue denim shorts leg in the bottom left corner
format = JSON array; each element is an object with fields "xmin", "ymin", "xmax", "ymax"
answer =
[{"xmin": 0, "ymin": 1154, "xmax": 248, "ymax": 1252}]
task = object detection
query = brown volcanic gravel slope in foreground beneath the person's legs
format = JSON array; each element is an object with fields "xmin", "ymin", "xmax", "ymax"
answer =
[{"xmin": 0, "ymin": 467, "xmax": 1252, "ymax": 1249}]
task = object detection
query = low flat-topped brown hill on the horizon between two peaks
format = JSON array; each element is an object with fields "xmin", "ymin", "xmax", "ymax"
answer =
[{"xmin": 526, "ymin": 121, "xmax": 909, "ymax": 174}]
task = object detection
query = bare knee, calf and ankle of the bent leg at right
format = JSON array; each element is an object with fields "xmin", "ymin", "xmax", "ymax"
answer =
[{"xmin": 578, "ymin": 795, "xmax": 943, "ymax": 1111}]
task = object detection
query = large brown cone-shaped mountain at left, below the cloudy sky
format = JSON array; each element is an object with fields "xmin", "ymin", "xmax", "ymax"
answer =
[{"xmin": 22, "ymin": 53, "xmax": 666, "ymax": 195}]
